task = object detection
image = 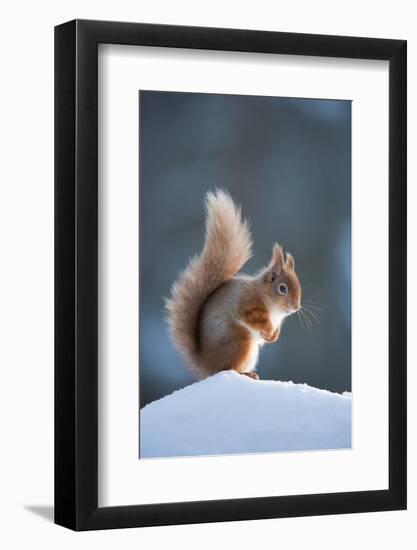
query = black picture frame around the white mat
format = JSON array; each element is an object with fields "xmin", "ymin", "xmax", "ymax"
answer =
[{"xmin": 55, "ymin": 20, "xmax": 407, "ymax": 530}]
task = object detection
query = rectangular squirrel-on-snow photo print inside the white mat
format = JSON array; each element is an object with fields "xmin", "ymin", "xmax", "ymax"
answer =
[{"xmin": 138, "ymin": 90, "xmax": 352, "ymax": 459}]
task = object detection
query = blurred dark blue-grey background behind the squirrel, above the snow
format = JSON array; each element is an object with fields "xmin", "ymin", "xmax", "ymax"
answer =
[{"xmin": 139, "ymin": 91, "xmax": 351, "ymax": 407}]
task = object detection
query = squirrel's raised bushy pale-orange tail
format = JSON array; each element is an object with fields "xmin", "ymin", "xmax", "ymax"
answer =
[{"xmin": 166, "ymin": 190, "xmax": 252, "ymax": 373}]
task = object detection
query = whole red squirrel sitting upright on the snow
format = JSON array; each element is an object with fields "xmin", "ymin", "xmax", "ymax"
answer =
[{"xmin": 166, "ymin": 190, "xmax": 301, "ymax": 379}]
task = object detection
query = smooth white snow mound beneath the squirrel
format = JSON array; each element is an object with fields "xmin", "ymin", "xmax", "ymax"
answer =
[{"xmin": 140, "ymin": 371, "xmax": 352, "ymax": 458}]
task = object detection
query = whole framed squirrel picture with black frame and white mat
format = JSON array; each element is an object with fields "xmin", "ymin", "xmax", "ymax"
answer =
[{"xmin": 55, "ymin": 20, "xmax": 406, "ymax": 530}]
